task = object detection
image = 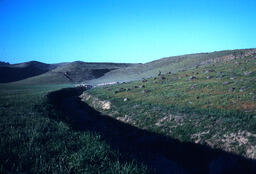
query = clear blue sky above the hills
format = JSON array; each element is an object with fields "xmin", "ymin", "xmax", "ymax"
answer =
[{"xmin": 0, "ymin": 0, "xmax": 256, "ymax": 63}]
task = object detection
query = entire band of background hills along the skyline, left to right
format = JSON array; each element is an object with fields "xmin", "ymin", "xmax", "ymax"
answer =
[{"xmin": 3, "ymin": 49, "xmax": 256, "ymax": 85}]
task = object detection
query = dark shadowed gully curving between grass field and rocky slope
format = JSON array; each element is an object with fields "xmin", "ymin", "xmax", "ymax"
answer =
[{"xmin": 48, "ymin": 88, "xmax": 256, "ymax": 174}]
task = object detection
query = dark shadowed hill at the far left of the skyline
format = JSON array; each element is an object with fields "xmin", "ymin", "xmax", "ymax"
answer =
[{"xmin": 0, "ymin": 61, "xmax": 62, "ymax": 83}]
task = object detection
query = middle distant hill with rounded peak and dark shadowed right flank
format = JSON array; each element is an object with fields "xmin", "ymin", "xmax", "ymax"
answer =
[{"xmin": 17, "ymin": 61, "xmax": 136, "ymax": 84}]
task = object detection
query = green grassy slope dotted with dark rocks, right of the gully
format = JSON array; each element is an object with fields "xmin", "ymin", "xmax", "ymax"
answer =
[{"xmin": 85, "ymin": 51, "xmax": 256, "ymax": 159}]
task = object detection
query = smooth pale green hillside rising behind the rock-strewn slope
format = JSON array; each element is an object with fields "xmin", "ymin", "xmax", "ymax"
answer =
[{"xmin": 89, "ymin": 49, "xmax": 255, "ymax": 85}]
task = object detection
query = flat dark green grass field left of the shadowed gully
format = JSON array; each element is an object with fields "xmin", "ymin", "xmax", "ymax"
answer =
[{"xmin": 0, "ymin": 84, "xmax": 149, "ymax": 174}]
